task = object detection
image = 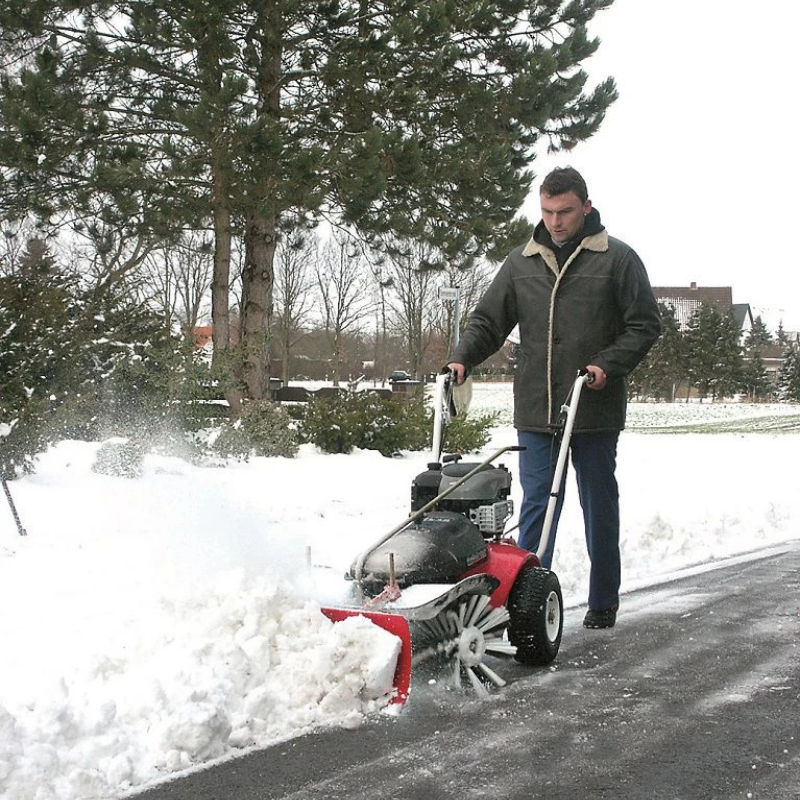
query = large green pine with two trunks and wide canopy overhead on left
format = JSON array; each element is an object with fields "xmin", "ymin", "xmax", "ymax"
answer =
[{"xmin": 0, "ymin": 0, "xmax": 616, "ymax": 397}]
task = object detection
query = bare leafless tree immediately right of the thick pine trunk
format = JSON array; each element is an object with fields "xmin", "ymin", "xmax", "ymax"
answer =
[{"xmin": 273, "ymin": 231, "xmax": 319, "ymax": 383}]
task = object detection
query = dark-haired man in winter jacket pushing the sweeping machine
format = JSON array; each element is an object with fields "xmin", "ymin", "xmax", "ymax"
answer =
[{"xmin": 449, "ymin": 167, "xmax": 661, "ymax": 628}]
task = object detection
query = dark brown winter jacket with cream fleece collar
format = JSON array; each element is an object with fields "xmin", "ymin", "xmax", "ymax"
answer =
[{"xmin": 451, "ymin": 211, "xmax": 661, "ymax": 432}]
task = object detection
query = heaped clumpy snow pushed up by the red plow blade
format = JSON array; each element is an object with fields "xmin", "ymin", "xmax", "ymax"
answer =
[{"xmin": 0, "ymin": 576, "xmax": 399, "ymax": 800}]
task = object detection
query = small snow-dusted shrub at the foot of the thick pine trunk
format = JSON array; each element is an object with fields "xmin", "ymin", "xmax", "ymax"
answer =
[{"xmin": 212, "ymin": 400, "xmax": 298, "ymax": 459}]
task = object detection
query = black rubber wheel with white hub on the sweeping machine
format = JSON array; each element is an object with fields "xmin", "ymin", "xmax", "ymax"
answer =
[{"xmin": 506, "ymin": 567, "xmax": 564, "ymax": 665}]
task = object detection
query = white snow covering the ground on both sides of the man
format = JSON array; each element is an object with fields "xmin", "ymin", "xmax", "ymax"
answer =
[{"xmin": 0, "ymin": 384, "xmax": 800, "ymax": 800}]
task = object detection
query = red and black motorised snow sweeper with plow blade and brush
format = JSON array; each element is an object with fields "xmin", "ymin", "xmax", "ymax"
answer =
[{"xmin": 322, "ymin": 369, "xmax": 591, "ymax": 705}]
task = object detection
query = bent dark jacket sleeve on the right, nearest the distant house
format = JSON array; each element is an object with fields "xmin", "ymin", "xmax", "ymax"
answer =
[{"xmin": 593, "ymin": 249, "xmax": 661, "ymax": 378}]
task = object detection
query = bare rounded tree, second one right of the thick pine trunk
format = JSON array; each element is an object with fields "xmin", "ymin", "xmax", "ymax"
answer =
[{"xmin": 316, "ymin": 232, "xmax": 373, "ymax": 386}]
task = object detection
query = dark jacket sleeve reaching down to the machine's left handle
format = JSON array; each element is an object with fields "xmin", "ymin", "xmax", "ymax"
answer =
[{"xmin": 450, "ymin": 256, "xmax": 518, "ymax": 370}]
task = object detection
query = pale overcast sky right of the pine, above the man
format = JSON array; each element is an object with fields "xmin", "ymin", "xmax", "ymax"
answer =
[{"xmin": 523, "ymin": 0, "xmax": 800, "ymax": 332}]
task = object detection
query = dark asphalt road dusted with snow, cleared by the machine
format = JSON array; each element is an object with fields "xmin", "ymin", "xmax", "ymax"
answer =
[{"xmin": 138, "ymin": 543, "xmax": 800, "ymax": 800}]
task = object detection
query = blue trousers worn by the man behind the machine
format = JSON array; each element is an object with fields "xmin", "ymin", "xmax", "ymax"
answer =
[{"xmin": 517, "ymin": 431, "xmax": 621, "ymax": 611}]
